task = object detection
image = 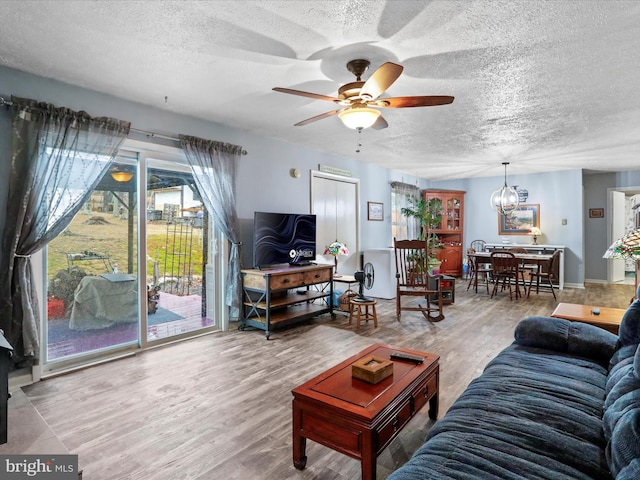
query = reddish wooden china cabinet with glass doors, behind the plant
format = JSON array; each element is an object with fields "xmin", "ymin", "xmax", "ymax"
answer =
[{"xmin": 423, "ymin": 190, "xmax": 466, "ymax": 277}]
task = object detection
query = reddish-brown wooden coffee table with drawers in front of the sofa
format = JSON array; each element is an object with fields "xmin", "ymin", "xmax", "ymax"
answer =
[{"xmin": 291, "ymin": 344, "xmax": 440, "ymax": 480}]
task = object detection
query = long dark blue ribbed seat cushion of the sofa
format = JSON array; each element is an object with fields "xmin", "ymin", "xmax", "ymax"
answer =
[{"xmin": 389, "ymin": 343, "xmax": 610, "ymax": 480}]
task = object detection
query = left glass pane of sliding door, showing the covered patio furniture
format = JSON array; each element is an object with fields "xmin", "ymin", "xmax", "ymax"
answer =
[{"xmin": 45, "ymin": 158, "xmax": 139, "ymax": 361}]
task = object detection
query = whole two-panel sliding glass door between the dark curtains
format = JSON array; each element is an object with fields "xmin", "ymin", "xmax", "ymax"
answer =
[{"xmin": 43, "ymin": 142, "xmax": 224, "ymax": 373}]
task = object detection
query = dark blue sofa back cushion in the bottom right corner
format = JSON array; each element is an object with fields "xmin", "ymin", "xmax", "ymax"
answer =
[{"xmin": 607, "ymin": 408, "xmax": 640, "ymax": 479}]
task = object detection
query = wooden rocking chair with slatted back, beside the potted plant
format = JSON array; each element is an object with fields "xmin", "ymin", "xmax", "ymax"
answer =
[{"xmin": 393, "ymin": 238, "xmax": 444, "ymax": 321}]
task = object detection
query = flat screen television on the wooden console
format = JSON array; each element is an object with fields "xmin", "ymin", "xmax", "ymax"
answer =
[{"xmin": 253, "ymin": 212, "xmax": 316, "ymax": 268}]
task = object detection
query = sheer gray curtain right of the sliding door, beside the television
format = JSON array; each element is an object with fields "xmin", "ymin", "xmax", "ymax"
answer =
[{"xmin": 180, "ymin": 135, "xmax": 243, "ymax": 320}]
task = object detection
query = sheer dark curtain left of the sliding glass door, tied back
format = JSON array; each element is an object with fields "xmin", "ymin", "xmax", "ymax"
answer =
[{"xmin": 0, "ymin": 97, "xmax": 130, "ymax": 367}]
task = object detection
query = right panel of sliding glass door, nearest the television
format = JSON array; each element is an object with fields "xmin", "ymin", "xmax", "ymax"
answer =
[{"xmin": 146, "ymin": 159, "xmax": 215, "ymax": 341}]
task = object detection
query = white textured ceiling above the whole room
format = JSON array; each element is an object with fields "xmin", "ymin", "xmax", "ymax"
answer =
[{"xmin": 0, "ymin": 0, "xmax": 640, "ymax": 179}]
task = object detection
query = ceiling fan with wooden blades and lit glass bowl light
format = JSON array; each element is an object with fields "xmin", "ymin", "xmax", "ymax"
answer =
[{"xmin": 273, "ymin": 59, "xmax": 453, "ymax": 130}]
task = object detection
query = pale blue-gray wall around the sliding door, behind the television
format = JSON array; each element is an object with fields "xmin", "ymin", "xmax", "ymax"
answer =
[{"xmin": 0, "ymin": 67, "xmax": 415, "ymax": 265}]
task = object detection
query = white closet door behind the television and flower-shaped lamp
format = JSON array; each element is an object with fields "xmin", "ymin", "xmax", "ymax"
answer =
[{"xmin": 311, "ymin": 172, "xmax": 360, "ymax": 275}]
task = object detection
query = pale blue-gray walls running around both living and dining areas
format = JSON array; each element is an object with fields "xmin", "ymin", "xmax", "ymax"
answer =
[{"xmin": 0, "ymin": 67, "xmax": 640, "ymax": 284}]
